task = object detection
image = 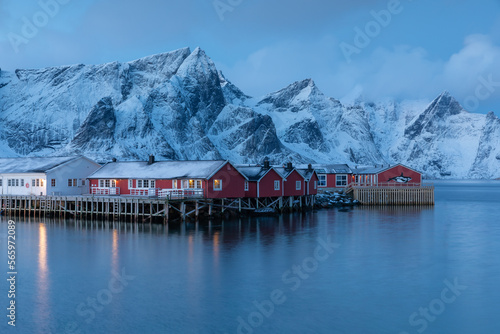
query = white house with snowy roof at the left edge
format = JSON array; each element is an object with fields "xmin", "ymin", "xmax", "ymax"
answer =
[{"xmin": 0, "ymin": 156, "xmax": 101, "ymax": 196}]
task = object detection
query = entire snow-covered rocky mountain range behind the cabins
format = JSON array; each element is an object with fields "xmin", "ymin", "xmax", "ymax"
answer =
[{"xmin": 0, "ymin": 48, "xmax": 500, "ymax": 178}]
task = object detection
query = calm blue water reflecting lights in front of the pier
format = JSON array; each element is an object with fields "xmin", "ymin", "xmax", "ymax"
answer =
[{"xmin": 0, "ymin": 182, "xmax": 500, "ymax": 334}]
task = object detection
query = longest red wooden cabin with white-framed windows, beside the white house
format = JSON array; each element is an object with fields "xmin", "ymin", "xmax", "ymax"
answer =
[{"xmin": 89, "ymin": 156, "xmax": 247, "ymax": 198}]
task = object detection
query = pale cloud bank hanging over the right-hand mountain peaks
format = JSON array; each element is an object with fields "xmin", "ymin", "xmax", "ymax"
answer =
[{"xmin": 220, "ymin": 34, "xmax": 500, "ymax": 112}]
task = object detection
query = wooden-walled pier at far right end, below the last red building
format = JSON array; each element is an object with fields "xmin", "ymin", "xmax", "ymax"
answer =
[{"xmin": 346, "ymin": 184, "xmax": 434, "ymax": 205}]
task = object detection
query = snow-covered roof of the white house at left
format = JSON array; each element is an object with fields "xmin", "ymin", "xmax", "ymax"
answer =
[{"xmin": 0, "ymin": 157, "xmax": 80, "ymax": 174}]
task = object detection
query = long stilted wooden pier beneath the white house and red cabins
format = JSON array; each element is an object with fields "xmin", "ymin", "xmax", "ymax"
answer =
[{"xmin": 0, "ymin": 195, "xmax": 314, "ymax": 223}]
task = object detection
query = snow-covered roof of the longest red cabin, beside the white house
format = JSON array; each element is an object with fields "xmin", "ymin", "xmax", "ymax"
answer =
[{"xmin": 89, "ymin": 160, "xmax": 227, "ymax": 179}]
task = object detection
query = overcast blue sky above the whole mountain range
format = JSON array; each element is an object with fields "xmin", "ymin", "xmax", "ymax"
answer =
[{"xmin": 0, "ymin": 0, "xmax": 500, "ymax": 115}]
